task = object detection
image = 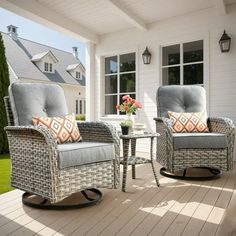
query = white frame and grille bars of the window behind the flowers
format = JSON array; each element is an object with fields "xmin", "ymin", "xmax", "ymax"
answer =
[{"xmin": 102, "ymin": 50, "xmax": 138, "ymax": 118}]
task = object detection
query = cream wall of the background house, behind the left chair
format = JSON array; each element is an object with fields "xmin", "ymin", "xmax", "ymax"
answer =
[{"xmin": 19, "ymin": 78, "xmax": 85, "ymax": 114}]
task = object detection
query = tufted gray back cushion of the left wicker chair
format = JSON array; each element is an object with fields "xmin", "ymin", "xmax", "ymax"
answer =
[{"xmin": 9, "ymin": 82, "xmax": 68, "ymax": 125}]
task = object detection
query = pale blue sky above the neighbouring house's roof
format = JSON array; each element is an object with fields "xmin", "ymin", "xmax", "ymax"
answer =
[{"xmin": 0, "ymin": 8, "xmax": 85, "ymax": 65}]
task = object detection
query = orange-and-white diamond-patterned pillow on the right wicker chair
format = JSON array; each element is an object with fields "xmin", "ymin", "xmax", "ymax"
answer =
[{"xmin": 168, "ymin": 111, "xmax": 209, "ymax": 133}]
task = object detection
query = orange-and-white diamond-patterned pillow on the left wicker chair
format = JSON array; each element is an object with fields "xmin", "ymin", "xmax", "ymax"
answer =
[{"xmin": 33, "ymin": 114, "xmax": 82, "ymax": 144}]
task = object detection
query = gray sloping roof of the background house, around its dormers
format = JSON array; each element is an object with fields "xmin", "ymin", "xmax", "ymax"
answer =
[{"xmin": 2, "ymin": 33, "xmax": 85, "ymax": 86}]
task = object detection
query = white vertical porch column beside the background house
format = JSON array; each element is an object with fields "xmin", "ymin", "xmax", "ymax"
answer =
[{"xmin": 85, "ymin": 42, "xmax": 95, "ymax": 121}]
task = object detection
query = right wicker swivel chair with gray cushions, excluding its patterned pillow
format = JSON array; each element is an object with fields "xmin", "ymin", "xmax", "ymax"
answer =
[{"xmin": 154, "ymin": 86, "xmax": 235, "ymax": 179}]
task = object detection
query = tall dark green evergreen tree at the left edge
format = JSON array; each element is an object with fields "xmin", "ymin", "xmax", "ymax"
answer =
[{"xmin": 0, "ymin": 33, "xmax": 10, "ymax": 153}]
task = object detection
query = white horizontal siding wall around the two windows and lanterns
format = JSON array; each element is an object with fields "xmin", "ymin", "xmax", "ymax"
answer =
[{"xmin": 95, "ymin": 4, "xmax": 236, "ymax": 157}]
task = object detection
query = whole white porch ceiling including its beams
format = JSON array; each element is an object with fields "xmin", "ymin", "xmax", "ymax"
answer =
[{"xmin": 0, "ymin": 0, "xmax": 236, "ymax": 43}]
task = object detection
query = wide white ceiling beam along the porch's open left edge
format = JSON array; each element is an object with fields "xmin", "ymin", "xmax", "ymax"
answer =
[{"xmin": 0, "ymin": 0, "xmax": 99, "ymax": 43}]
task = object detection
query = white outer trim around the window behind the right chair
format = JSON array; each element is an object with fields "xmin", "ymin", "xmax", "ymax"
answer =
[{"xmin": 157, "ymin": 32, "xmax": 211, "ymax": 113}]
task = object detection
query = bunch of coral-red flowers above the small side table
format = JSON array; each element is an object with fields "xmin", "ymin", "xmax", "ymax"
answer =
[{"xmin": 116, "ymin": 95, "xmax": 142, "ymax": 114}]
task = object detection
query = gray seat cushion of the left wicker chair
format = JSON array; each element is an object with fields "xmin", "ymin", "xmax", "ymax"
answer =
[{"xmin": 58, "ymin": 142, "xmax": 115, "ymax": 169}]
